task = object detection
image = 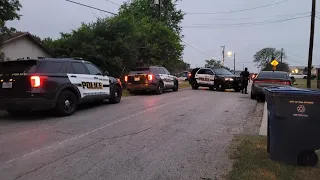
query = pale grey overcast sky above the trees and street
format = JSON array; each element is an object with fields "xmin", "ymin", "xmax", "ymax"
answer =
[{"xmin": 8, "ymin": 0, "xmax": 320, "ymax": 72}]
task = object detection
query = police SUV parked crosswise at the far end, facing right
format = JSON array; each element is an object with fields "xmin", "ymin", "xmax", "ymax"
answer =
[{"xmin": 189, "ymin": 67, "xmax": 242, "ymax": 92}]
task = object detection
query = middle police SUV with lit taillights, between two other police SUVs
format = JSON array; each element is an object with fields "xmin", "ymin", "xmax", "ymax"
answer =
[{"xmin": 125, "ymin": 66, "xmax": 179, "ymax": 94}]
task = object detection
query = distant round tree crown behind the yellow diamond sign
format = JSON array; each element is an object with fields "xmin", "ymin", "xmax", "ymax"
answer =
[{"xmin": 253, "ymin": 48, "xmax": 286, "ymax": 67}]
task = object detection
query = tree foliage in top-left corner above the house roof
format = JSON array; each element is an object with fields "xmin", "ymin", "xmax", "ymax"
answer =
[{"xmin": 0, "ymin": 0, "xmax": 21, "ymax": 61}]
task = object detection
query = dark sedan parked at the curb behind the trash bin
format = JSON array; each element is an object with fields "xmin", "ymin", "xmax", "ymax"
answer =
[{"xmin": 251, "ymin": 71, "xmax": 292, "ymax": 99}]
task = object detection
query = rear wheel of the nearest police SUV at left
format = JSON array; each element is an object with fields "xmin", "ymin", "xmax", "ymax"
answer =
[{"xmin": 55, "ymin": 90, "xmax": 78, "ymax": 116}]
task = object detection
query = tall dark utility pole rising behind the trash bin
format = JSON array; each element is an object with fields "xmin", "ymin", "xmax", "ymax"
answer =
[{"xmin": 307, "ymin": 0, "xmax": 316, "ymax": 88}]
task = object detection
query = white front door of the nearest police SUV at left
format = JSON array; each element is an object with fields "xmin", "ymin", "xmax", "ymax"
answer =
[{"xmin": 85, "ymin": 63, "xmax": 110, "ymax": 95}]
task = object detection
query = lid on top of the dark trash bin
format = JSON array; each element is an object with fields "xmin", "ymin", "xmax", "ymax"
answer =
[{"xmin": 263, "ymin": 86, "xmax": 320, "ymax": 97}]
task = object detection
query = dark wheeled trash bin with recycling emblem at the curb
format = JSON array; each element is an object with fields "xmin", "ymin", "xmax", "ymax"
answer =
[{"xmin": 263, "ymin": 87, "xmax": 320, "ymax": 166}]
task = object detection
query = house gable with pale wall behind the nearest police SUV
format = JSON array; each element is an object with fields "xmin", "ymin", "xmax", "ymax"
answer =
[{"xmin": 0, "ymin": 32, "xmax": 53, "ymax": 61}]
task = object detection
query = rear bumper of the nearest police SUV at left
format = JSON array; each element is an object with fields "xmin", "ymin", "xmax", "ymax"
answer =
[{"xmin": 0, "ymin": 98, "xmax": 57, "ymax": 111}]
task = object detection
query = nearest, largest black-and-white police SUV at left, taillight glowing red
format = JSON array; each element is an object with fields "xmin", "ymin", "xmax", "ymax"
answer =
[{"xmin": 0, "ymin": 58, "xmax": 122, "ymax": 116}]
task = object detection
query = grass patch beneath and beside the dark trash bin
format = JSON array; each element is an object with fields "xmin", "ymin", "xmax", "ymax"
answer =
[{"xmin": 227, "ymin": 136, "xmax": 320, "ymax": 180}]
